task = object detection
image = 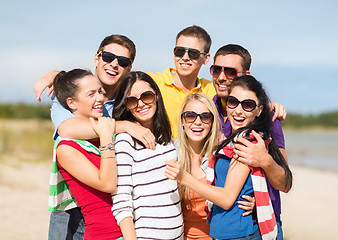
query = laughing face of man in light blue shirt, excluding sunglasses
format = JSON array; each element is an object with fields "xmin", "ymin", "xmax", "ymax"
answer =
[{"xmin": 95, "ymin": 43, "xmax": 132, "ymax": 89}]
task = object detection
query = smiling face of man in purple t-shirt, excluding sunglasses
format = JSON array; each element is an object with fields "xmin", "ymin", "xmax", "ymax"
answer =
[{"xmin": 212, "ymin": 54, "xmax": 250, "ymax": 98}]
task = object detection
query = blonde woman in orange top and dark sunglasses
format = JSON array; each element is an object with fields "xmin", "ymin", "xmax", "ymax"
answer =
[{"xmin": 176, "ymin": 93, "xmax": 254, "ymax": 240}]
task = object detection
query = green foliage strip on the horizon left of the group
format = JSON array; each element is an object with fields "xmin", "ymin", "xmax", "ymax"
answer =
[{"xmin": 0, "ymin": 103, "xmax": 50, "ymax": 119}]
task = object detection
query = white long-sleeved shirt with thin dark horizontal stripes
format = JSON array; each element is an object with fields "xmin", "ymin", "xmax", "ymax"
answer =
[{"xmin": 112, "ymin": 133, "xmax": 183, "ymax": 239}]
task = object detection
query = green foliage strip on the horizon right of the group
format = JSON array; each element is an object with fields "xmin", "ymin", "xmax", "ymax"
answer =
[{"xmin": 283, "ymin": 111, "xmax": 338, "ymax": 128}]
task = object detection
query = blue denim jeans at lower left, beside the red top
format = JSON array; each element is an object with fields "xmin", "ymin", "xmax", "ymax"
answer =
[{"xmin": 48, "ymin": 207, "xmax": 85, "ymax": 240}]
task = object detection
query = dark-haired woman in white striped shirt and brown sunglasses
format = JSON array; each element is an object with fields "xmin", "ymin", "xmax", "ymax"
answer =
[{"xmin": 112, "ymin": 72, "xmax": 183, "ymax": 240}]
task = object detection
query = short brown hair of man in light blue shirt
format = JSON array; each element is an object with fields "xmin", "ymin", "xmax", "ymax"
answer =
[{"xmin": 97, "ymin": 34, "xmax": 136, "ymax": 62}]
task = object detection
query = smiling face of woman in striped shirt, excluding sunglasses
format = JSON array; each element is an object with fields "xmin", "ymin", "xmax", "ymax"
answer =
[{"xmin": 128, "ymin": 80, "xmax": 157, "ymax": 129}]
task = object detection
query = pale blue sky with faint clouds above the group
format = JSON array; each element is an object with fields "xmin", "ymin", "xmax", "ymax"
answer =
[{"xmin": 0, "ymin": 0, "xmax": 338, "ymax": 114}]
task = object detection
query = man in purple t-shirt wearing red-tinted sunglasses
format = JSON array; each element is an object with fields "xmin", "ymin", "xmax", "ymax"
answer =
[{"xmin": 210, "ymin": 44, "xmax": 289, "ymax": 239}]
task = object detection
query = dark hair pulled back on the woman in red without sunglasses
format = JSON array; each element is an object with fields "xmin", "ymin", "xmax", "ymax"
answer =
[{"xmin": 53, "ymin": 69, "xmax": 93, "ymax": 111}]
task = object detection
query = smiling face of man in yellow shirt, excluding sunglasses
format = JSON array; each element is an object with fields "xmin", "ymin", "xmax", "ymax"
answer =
[{"xmin": 174, "ymin": 35, "xmax": 210, "ymax": 77}]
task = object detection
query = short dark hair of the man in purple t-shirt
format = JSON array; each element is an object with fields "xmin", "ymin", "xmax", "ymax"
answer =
[{"xmin": 214, "ymin": 44, "xmax": 251, "ymax": 71}]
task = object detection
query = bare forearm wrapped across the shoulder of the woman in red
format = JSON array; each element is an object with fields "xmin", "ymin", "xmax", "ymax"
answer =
[{"xmin": 57, "ymin": 117, "xmax": 98, "ymax": 139}]
